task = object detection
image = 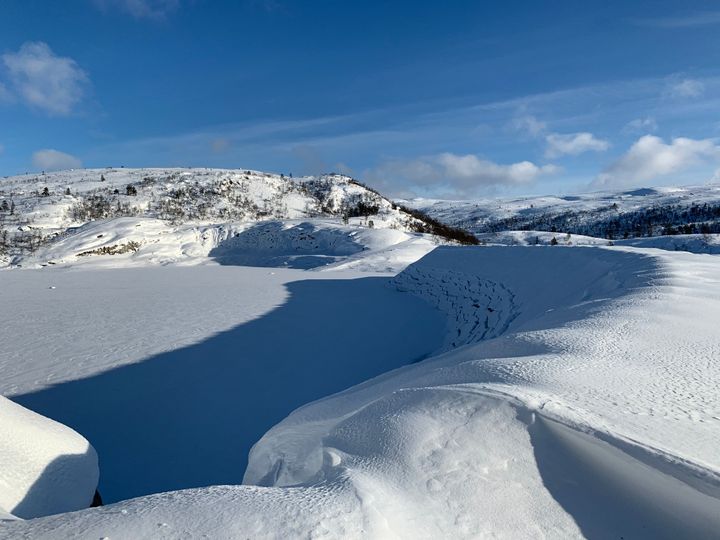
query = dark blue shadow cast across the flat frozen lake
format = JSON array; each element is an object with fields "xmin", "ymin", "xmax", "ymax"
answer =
[{"xmin": 14, "ymin": 277, "xmax": 444, "ymax": 502}]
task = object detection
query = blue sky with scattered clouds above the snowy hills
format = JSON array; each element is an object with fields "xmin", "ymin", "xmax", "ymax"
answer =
[{"xmin": 0, "ymin": 0, "xmax": 720, "ymax": 198}]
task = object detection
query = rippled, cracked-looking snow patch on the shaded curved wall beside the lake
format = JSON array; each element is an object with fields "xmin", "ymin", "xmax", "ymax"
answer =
[{"xmin": 393, "ymin": 265, "xmax": 517, "ymax": 349}]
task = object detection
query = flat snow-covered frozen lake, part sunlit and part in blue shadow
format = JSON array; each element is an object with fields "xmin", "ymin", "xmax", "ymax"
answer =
[{"xmin": 0, "ymin": 266, "xmax": 443, "ymax": 502}]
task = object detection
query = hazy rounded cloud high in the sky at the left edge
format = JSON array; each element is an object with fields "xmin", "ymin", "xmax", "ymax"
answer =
[{"xmin": 2, "ymin": 41, "xmax": 88, "ymax": 115}]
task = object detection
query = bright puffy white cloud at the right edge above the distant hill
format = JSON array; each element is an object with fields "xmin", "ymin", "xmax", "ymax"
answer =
[{"xmin": 595, "ymin": 135, "xmax": 720, "ymax": 187}]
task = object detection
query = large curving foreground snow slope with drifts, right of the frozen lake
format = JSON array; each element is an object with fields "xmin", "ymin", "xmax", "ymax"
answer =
[{"xmin": 0, "ymin": 245, "xmax": 720, "ymax": 538}]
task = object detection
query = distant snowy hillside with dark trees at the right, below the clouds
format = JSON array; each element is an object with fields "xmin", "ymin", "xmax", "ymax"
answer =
[{"xmin": 405, "ymin": 184, "xmax": 720, "ymax": 239}]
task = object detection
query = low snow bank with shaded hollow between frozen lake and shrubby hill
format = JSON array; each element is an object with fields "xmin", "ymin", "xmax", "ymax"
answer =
[{"xmin": 18, "ymin": 217, "xmax": 438, "ymax": 273}]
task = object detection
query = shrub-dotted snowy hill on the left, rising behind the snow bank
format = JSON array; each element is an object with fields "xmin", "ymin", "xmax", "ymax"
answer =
[{"xmin": 0, "ymin": 168, "xmax": 475, "ymax": 266}]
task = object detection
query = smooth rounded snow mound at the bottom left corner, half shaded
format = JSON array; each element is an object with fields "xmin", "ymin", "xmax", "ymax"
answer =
[{"xmin": 0, "ymin": 396, "xmax": 98, "ymax": 518}]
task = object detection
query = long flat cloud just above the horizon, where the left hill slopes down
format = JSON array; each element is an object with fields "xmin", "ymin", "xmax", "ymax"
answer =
[{"xmin": 364, "ymin": 152, "xmax": 560, "ymax": 197}]
